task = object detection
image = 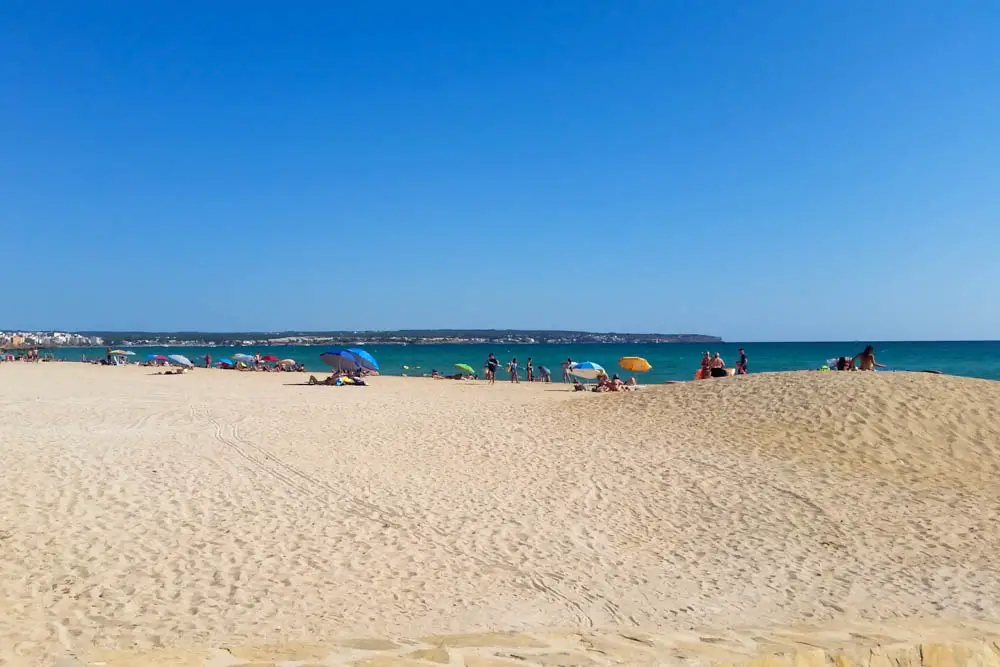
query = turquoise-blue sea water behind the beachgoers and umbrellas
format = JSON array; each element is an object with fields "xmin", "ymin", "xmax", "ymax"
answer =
[{"xmin": 55, "ymin": 341, "xmax": 1000, "ymax": 383}]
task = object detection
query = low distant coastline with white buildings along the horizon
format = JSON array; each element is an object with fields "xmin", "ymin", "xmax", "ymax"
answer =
[{"xmin": 0, "ymin": 329, "xmax": 722, "ymax": 349}]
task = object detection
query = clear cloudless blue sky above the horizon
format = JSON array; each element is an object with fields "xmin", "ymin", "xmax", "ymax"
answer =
[{"xmin": 0, "ymin": 0, "xmax": 1000, "ymax": 340}]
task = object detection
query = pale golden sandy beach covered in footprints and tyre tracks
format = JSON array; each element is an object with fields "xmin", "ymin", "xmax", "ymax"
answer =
[{"xmin": 0, "ymin": 363, "xmax": 1000, "ymax": 664}]
